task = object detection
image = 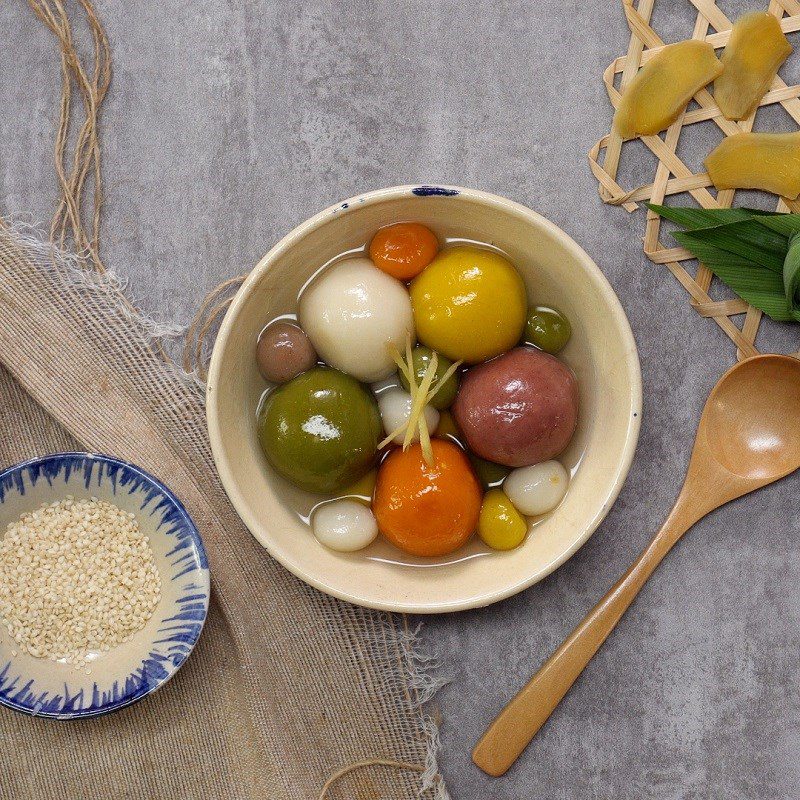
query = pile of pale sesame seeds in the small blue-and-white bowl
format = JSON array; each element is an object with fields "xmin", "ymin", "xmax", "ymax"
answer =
[{"xmin": 0, "ymin": 496, "xmax": 161, "ymax": 674}]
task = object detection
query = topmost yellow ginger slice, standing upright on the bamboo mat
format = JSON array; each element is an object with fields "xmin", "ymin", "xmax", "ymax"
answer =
[{"xmin": 714, "ymin": 11, "xmax": 792, "ymax": 119}]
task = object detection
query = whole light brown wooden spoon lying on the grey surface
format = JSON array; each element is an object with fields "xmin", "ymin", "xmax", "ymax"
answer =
[{"xmin": 472, "ymin": 355, "xmax": 800, "ymax": 776}]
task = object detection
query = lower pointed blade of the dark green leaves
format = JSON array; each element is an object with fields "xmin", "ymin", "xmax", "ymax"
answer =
[{"xmin": 673, "ymin": 232, "xmax": 800, "ymax": 322}]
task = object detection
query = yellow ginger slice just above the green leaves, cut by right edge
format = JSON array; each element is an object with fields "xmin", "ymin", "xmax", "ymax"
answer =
[{"xmin": 706, "ymin": 131, "xmax": 800, "ymax": 200}]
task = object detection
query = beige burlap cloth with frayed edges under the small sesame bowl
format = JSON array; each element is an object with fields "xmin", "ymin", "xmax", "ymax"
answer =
[{"xmin": 0, "ymin": 222, "xmax": 446, "ymax": 800}]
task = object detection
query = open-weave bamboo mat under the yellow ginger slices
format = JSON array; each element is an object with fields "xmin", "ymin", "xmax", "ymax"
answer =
[{"xmin": 589, "ymin": 0, "xmax": 800, "ymax": 360}]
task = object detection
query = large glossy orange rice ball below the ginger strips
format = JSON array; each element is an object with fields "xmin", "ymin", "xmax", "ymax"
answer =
[{"xmin": 372, "ymin": 439, "xmax": 482, "ymax": 556}]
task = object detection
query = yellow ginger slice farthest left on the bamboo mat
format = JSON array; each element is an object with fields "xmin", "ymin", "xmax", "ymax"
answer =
[{"xmin": 614, "ymin": 39, "xmax": 722, "ymax": 139}]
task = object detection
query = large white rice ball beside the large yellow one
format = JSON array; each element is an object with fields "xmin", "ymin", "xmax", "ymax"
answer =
[{"xmin": 298, "ymin": 258, "xmax": 415, "ymax": 383}]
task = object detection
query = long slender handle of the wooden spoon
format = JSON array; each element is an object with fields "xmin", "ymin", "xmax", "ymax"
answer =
[{"xmin": 472, "ymin": 498, "xmax": 702, "ymax": 777}]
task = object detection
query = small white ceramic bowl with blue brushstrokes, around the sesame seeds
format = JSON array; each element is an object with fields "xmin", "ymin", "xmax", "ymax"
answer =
[{"xmin": 0, "ymin": 453, "xmax": 210, "ymax": 720}]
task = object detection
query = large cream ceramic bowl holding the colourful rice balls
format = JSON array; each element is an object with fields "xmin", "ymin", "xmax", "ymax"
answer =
[{"xmin": 207, "ymin": 186, "xmax": 641, "ymax": 613}]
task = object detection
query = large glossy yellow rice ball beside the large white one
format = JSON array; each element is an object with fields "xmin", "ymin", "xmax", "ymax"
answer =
[{"xmin": 410, "ymin": 247, "xmax": 528, "ymax": 364}]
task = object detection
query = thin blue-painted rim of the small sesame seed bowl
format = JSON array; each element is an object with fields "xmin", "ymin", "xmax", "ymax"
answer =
[{"xmin": 0, "ymin": 451, "xmax": 211, "ymax": 721}]
